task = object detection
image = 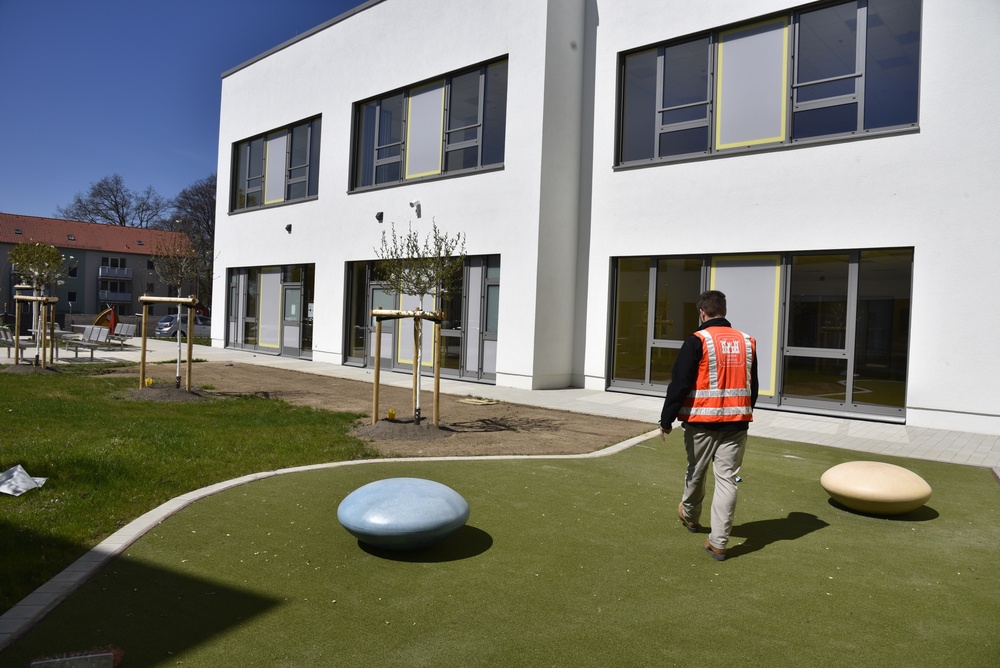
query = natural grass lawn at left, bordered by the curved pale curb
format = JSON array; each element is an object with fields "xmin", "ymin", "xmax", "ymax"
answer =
[{"xmin": 0, "ymin": 365, "xmax": 372, "ymax": 611}]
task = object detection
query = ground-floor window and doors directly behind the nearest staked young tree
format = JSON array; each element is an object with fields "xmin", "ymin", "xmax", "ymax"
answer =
[{"xmin": 344, "ymin": 255, "xmax": 500, "ymax": 382}]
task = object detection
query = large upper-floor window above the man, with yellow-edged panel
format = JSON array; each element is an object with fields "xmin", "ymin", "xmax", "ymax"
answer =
[{"xmin": 617, "ymin": 0, "xmax": 920, "ymax": 165}]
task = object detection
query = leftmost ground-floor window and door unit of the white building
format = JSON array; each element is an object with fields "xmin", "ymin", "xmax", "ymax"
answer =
[{"xmin": 226, "ymin": 264, "xmax": 315, "ymax": 359}]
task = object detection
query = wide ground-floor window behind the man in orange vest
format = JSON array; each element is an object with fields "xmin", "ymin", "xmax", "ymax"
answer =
[{"xmin": 609, "ymin": 248, "xmax": 913, "ymax": 418}]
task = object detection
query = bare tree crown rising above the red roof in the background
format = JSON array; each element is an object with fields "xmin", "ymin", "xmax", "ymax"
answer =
[{"xmin": 56, "ymin": 174, "xmax": 170, "ymax": 227}]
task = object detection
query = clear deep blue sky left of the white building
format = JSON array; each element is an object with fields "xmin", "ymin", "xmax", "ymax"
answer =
[{"xmin": 0, "ymin": 0, "xmax": 362, "ymax": 216}]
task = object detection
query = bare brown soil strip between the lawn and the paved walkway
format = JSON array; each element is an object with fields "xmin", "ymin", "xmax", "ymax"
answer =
[{"xmin": 103, "ymin": 362, "xmax": 652, "ymax": 457}]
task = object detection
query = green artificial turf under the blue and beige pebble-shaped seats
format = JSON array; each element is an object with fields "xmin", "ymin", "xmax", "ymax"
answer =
[{"xmin": 0, "ymin": 434, "xmax": 1000, "ymax": 668}]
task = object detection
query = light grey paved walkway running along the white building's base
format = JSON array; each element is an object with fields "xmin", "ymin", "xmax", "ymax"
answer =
[{"xmin": 43, "ymin": 339, "xmax": 1000, "ymax": 473}]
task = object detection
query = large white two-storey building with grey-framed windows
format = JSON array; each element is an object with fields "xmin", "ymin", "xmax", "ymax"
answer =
[{"xmin": 213, "ymin": 0, "xmax": 1000, "ymax": 434}]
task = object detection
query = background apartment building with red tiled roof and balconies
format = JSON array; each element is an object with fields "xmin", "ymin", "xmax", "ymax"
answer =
[{"xmin": 0, "ymin": 213, "xmax": 191, "ymax": 327}]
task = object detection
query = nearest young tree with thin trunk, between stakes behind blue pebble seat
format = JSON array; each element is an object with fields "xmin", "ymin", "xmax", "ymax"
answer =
[{"xmin": 375, "ymin": 223, "xmax": 465, "ymax": 423}]
